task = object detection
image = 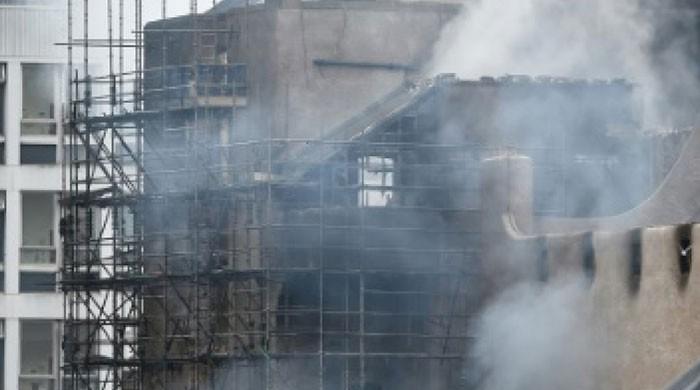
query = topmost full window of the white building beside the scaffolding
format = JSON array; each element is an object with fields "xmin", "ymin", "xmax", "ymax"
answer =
[{"xmin": 22, "ymin": 64, "xmax": 56, "ymax": 135}]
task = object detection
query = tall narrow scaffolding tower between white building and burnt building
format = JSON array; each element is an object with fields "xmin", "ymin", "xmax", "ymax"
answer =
[{"xmin": 61, "ymin": 0, "xmax": 145, "ymax": 389}]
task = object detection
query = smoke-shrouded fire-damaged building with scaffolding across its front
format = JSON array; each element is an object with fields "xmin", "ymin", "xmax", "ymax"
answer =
[{"xmin": 62, "ymin": 1, "xmax": 700, "ymax": 390}]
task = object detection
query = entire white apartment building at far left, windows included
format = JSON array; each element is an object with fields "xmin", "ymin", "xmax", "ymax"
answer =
[{"xmin": 0, "ymin": 0, "xmax": 67, "ymax": 390}]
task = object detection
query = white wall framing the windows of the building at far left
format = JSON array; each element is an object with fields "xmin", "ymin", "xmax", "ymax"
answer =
[{"xmin": 0, "ymin": 0, "xmax": 66, "ymax": 390}]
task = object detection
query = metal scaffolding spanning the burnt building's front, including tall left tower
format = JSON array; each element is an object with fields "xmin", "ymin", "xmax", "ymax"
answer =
[{"xmin": 61, "ymin": 0, "xmax": 476, "ymax": 390}]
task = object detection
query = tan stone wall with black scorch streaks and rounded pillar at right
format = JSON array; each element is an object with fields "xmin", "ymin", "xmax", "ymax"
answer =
[{"xmin": 483, "ymin": 156, "xmax": 700, "ymax": 389}]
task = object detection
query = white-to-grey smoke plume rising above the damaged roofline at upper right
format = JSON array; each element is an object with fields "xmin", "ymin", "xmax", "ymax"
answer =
[{"xmin": 430, "ymin": 0, "xmax": 698, "ymax": 127}]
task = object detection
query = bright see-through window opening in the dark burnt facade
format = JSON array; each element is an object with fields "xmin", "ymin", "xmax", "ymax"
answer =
[{"xmin": 358, "ymin": 156, "xmax": 394, "ymax": 207}]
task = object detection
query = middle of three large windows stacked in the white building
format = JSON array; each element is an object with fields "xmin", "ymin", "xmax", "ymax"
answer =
[{"xmin": 20, "ymin": 192, "xmax": 56, "ymax": 264}]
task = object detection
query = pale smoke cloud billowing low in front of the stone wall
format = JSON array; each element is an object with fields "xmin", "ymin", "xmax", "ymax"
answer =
[{"xmin": 466, "ymin": 280, "xmax": 610, "ymax": 390}]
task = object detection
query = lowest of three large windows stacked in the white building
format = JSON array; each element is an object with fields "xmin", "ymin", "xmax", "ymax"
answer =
[{"xmin": 19, "ymin": 321, "xmax": 58, "ymax": 390}]
